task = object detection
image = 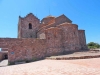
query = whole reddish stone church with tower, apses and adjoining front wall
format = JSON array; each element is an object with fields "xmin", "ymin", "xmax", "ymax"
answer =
[{"xmin": 0, "ymin": 13, "xmax": 87, "ymax": 63}]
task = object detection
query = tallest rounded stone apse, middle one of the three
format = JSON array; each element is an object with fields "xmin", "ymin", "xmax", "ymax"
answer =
[{"xmin": 57, "ymin": 23, "xmax": 79, "ymax": 53}]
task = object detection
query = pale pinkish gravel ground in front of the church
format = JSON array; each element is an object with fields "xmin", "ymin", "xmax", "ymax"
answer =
[{"xmin": 0, "ymin": 58, "xmax": 100, "ymax": 75}]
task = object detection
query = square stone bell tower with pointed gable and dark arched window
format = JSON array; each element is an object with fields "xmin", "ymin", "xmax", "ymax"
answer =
[{"xmin": 18, "ymin": 13, "xmax": 40, "ymax": 38}]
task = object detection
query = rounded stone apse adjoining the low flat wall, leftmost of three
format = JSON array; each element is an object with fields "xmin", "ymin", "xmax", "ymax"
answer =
[{"xmin": 45, "ymin": 27, "xmax": 63, "ymax": 56}]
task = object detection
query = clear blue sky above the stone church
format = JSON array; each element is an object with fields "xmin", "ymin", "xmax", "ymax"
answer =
[{"xmin": 0, "ymin": 0, "xmax": 100, "ymax": 43}]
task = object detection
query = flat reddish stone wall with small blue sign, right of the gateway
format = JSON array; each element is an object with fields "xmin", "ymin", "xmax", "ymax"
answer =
[{"xmin": 8, "ymin": 38, "xmax": 46, "ymax": 63}]
